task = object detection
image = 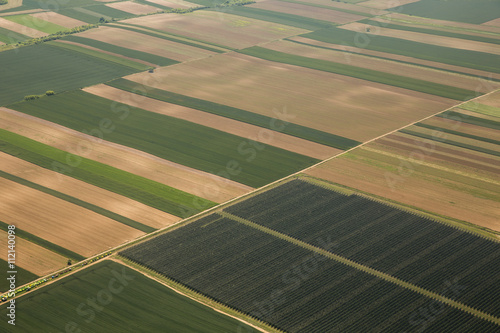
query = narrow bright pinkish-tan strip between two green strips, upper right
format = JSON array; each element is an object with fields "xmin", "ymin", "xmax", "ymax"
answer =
[{"xmin": 342, "ymin": 22, "xmax": 500, "ymax": 55}]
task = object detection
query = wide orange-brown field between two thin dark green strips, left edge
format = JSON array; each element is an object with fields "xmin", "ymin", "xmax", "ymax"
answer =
[{"xmin": 0, "ymin": 178, "xmax": 144, "ymax": 257}]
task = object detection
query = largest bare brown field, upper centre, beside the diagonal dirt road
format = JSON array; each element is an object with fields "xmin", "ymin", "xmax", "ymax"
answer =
[{"xmin": 127, "ymin": 53, "xmax": 455, "ymax": 141}]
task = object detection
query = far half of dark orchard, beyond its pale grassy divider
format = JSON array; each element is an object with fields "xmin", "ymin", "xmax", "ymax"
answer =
[{"xmin": 225, "ymin": 180, "xmax": 500, "ymax": 315}]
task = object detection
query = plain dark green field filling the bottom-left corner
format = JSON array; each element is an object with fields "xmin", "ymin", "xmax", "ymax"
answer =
[{"xmin": 0, "ymin": 260, "xmax": 254, "ymax": 333}]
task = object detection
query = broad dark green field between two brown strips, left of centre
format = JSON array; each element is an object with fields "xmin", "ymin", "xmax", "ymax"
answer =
[{"xmin": 9, "ymin": 91, "xmax": 318, "ymax": 187}]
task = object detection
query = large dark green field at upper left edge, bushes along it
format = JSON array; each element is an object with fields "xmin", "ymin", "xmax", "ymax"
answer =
[{"xmin": 0, "ymin": 44, "xmax": 143, "ymax": 106}]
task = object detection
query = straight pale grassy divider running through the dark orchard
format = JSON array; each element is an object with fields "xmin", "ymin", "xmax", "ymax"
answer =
[{"xmin": 218, "ymin": 211, "xmax": 500, "ymax": 325}]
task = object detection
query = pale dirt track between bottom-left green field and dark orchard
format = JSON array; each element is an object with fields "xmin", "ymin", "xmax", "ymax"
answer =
[{"xmin": 114, "ymin": 256, "xmax": 281, "ymax": 333}]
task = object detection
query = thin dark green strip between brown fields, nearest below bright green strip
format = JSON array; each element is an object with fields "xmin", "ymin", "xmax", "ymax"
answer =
[{"xmin": 0, "ymin": 170, "xmax": 156, "ymax": 233}]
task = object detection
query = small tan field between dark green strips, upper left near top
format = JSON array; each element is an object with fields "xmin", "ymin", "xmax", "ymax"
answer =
[{"xmin": 76, "ymin": 26, "xmax": 215, "ymax": 61}]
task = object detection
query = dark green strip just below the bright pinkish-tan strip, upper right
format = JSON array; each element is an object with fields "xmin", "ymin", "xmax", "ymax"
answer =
[{"xmin": 302, "ymin": 28, "xmax": 500, "ymax": 73}]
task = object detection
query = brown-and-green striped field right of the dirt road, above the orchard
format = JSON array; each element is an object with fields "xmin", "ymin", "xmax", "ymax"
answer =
[{"xmin": 308, "ymin": 93, "xmax": 500, "ymax": 231}]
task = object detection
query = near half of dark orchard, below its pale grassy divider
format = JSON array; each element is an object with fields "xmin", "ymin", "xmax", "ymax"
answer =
[{"xmin": 120, "ymin": 214, "xmax": 496, "ymax": 332}]
